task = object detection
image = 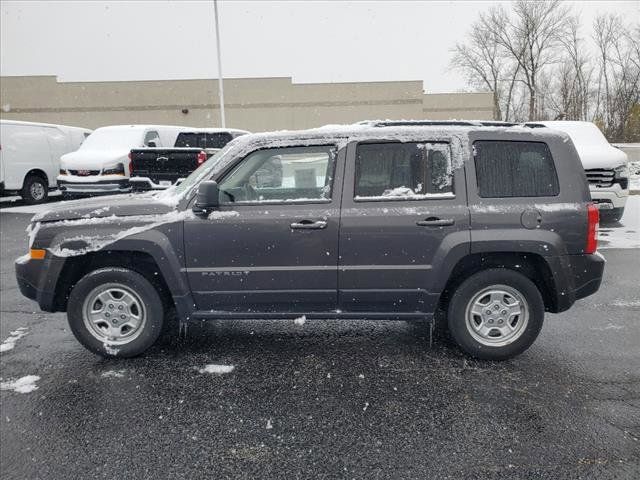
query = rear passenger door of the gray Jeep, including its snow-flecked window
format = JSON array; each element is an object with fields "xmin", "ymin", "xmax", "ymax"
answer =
[{"xmin": 338, "ymin": 137, "xmax": 469, "ymax": 313}]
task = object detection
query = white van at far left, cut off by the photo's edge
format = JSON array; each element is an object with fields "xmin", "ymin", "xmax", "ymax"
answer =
[{"xmin": 0, "ymin": 120, "xmax": 91, "ymax": 203}]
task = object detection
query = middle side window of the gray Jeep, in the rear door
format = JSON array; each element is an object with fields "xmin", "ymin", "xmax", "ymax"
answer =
[{"xmin": 355, "ymin": 142, "xmax": 453, "ymax": 201}]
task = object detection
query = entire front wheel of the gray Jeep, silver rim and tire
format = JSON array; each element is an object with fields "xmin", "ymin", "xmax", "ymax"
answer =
[{"xmin": 67, "ymin": 267, "xmax": 164, "ymax": 357}]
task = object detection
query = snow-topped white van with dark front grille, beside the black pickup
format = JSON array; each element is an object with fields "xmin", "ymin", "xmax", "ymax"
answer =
[{"xmin": 58, "ymin": 125, "xmax": 189, "ymax": 197}]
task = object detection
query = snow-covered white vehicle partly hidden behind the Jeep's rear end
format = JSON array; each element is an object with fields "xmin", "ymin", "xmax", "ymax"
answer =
[{"xmin": 531, "ymin": 121, "xmax": 629, "ymax": 222}]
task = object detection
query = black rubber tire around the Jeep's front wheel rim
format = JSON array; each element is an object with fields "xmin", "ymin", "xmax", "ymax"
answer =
[{"xmin": 67, "ymin": 267, "xmax": 165, "ymax": 358}]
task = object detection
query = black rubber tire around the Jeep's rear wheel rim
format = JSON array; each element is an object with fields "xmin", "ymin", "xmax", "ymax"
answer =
[{"xmin": 447, "ymin": 269, "xmax": 544, "ymax": 360}]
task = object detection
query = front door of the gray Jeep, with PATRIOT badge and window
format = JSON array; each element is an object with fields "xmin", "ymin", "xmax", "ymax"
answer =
[{"xmin": 184, "ymin": 144, "xmax": 344, "ymax": 313}]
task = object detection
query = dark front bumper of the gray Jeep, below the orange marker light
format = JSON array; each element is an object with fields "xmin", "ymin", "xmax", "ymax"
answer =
[{"xmin": 15, "ymin": 254, "xmax": 64, "ymax": 312}]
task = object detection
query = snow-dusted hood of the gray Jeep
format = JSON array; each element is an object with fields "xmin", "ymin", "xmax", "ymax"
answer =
[{"xmin": 31, "ymin": 193, "xmax": 175, "ymax": 222}]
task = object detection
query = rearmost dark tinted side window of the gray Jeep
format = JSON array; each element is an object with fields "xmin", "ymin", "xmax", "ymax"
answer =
[{"xmin": 473, "ymin": 140, "xmax": 560, "ymax": 198}]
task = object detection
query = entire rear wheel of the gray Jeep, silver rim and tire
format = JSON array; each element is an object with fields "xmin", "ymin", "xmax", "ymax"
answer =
[{"xmin": 448, "ymin": 269, "xmax": 544, "ymax": 360}]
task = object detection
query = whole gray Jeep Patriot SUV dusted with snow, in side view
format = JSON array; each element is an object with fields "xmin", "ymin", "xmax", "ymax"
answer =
[{"xmin": 16, "ymin": 122, "xmax": 604, "ymax": 359}]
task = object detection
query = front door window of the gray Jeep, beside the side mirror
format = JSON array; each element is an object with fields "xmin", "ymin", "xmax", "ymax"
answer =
[{"xmin": 220, "ymin": 142, "xmax": 336, "ymax": 203}]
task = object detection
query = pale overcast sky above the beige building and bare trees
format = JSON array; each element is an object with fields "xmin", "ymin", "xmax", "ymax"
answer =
[{"xmin": 0, "ymin": 0, "xmax": 640, "ymax": 92}]
